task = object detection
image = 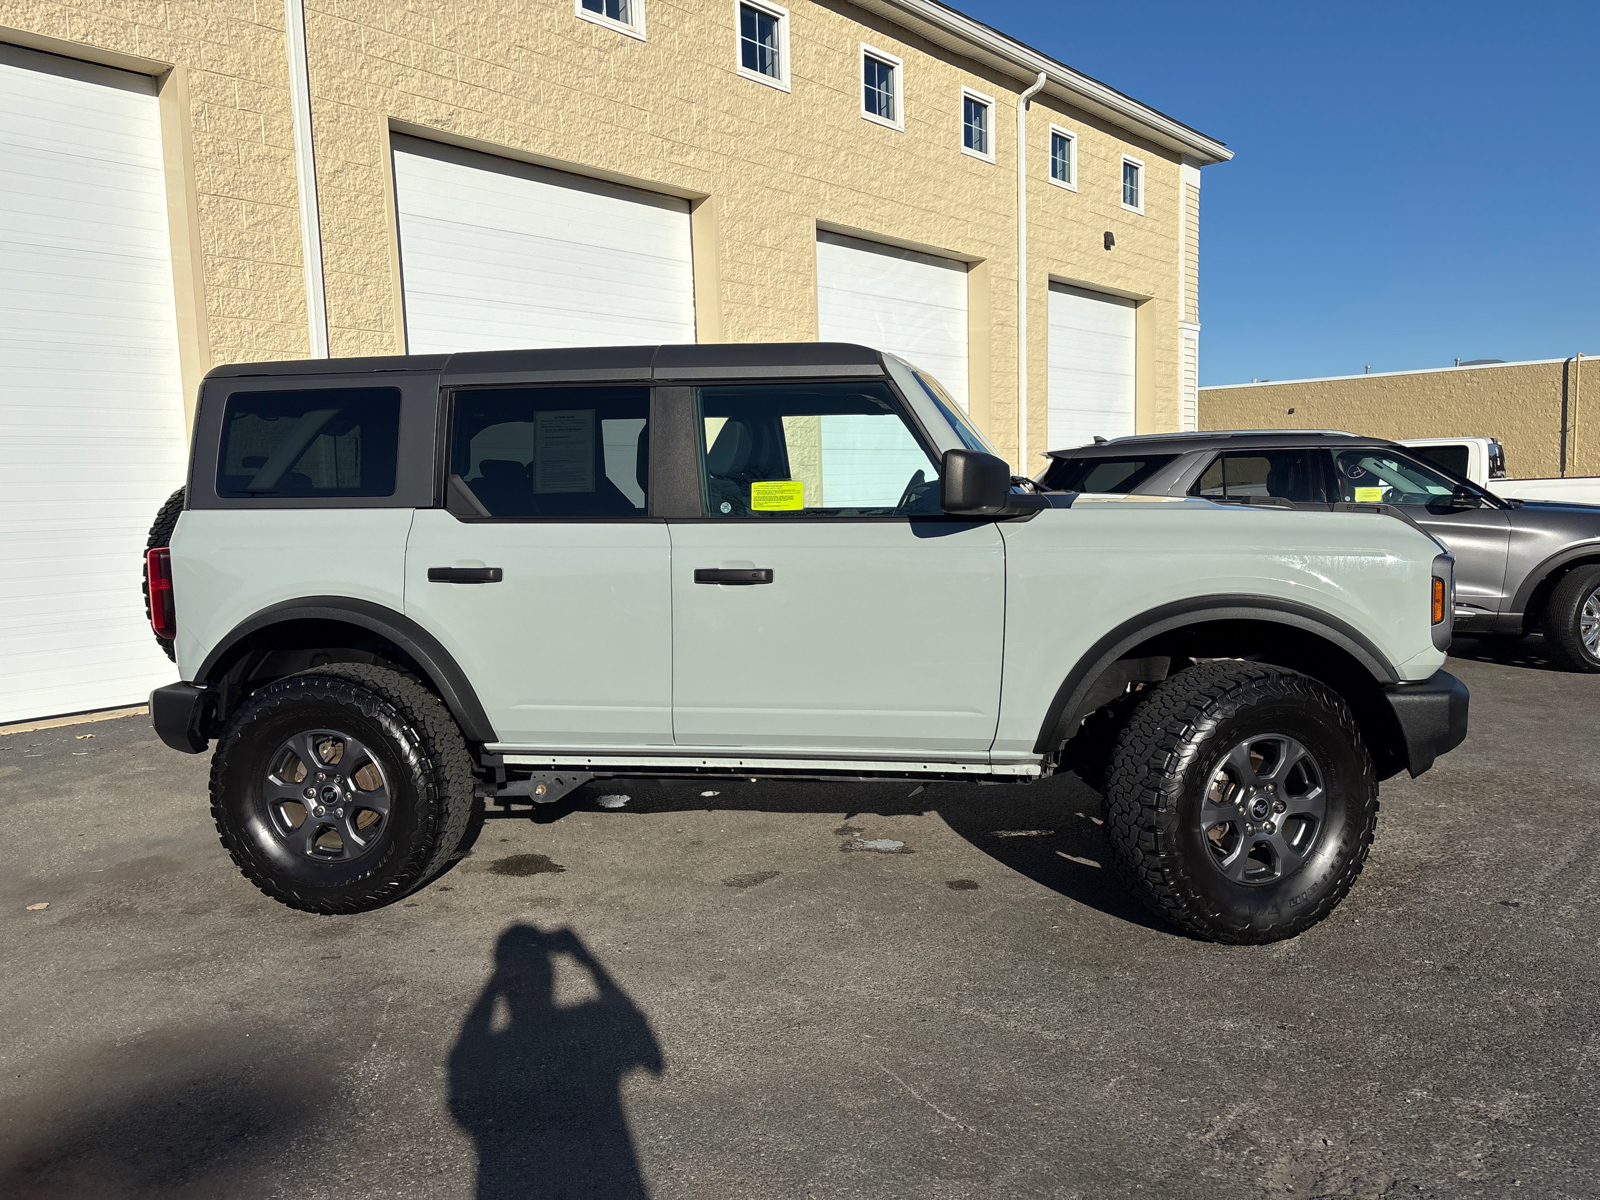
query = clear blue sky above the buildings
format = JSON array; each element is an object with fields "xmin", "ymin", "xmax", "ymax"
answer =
[{"xmin": 954, "ymin": 0, "xmax": 1600, "ymax": 384}]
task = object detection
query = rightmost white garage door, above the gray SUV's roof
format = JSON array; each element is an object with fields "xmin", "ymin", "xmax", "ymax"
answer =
[{"xmin": 1048, "ymin": 283, "xmax": 1134, "ymax": 450}]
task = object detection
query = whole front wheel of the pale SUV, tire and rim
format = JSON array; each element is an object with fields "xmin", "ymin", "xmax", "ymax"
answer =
[{"xmin": 1106, "ymin": 661, "xmax": 1378, "ymax": 944}]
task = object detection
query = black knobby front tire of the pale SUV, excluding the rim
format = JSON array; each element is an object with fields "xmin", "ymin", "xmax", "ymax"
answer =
[{"xmin": 1106, "ymin": 661, "xmax": 1378, "ymax": 944}]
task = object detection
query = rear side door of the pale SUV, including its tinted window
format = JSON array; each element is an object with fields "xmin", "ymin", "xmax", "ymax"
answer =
[{"xmin": 405, "ymin": 386, "xmax": 672, "ymax": 749}]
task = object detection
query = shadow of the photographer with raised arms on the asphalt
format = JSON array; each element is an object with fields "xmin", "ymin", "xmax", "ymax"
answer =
[{"xmin": 450, "ymin": 925, "xmax": 664, "ymax": 1200}]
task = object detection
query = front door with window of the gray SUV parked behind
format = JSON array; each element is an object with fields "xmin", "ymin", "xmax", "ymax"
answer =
[{"xmin": 1333, "ymin": 448, "xmax": 1510, "ymax": 613}]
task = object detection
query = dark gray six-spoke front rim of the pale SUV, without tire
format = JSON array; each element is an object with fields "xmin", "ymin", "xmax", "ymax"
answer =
[{"xmin": 1198, "ymin": 733, "xmax": 1328, "ymax": 886}]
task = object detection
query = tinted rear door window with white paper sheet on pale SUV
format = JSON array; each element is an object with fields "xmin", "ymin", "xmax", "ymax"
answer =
[{"xmin": 450, "ymin": 387, "xmax": 650, "ymax": 520}]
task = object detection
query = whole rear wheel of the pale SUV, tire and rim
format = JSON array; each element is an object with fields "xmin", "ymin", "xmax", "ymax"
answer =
[{"xmin": 211, "ymin": 664, "xmax": 474, "ymax": 914}]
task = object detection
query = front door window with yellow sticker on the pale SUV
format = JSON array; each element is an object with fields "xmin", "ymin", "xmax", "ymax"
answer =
[{"xmin": 699, "ymin": 382, "xmax": 941, "ymax": 518}]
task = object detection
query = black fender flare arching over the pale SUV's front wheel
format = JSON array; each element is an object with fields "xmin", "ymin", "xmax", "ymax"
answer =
[{"xmin": 1034, "ymin": 595, "xmax": 1400, "ymax": 754}]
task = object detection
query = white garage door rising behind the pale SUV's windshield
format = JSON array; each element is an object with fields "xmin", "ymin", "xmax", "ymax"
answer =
[{"xmin": 816, "ymin": 232, "xmax": 966, "ymax": 411}]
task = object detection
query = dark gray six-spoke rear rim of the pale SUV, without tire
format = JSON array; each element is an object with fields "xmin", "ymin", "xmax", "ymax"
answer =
[{"xmin": 261, "ymin": 730, "xmax": 390, "ymax": 862}]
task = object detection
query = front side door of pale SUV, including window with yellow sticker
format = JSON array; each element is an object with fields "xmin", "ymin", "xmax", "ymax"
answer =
[{"xmin": 669, "ymin": 381, "xmax": 1005, "ymax": 758}]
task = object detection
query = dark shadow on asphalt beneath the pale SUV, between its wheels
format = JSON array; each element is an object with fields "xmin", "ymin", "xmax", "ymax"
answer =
[{"xmin": 486, "ymin": 774, "xmax": 1187, "ymax": 938}]
